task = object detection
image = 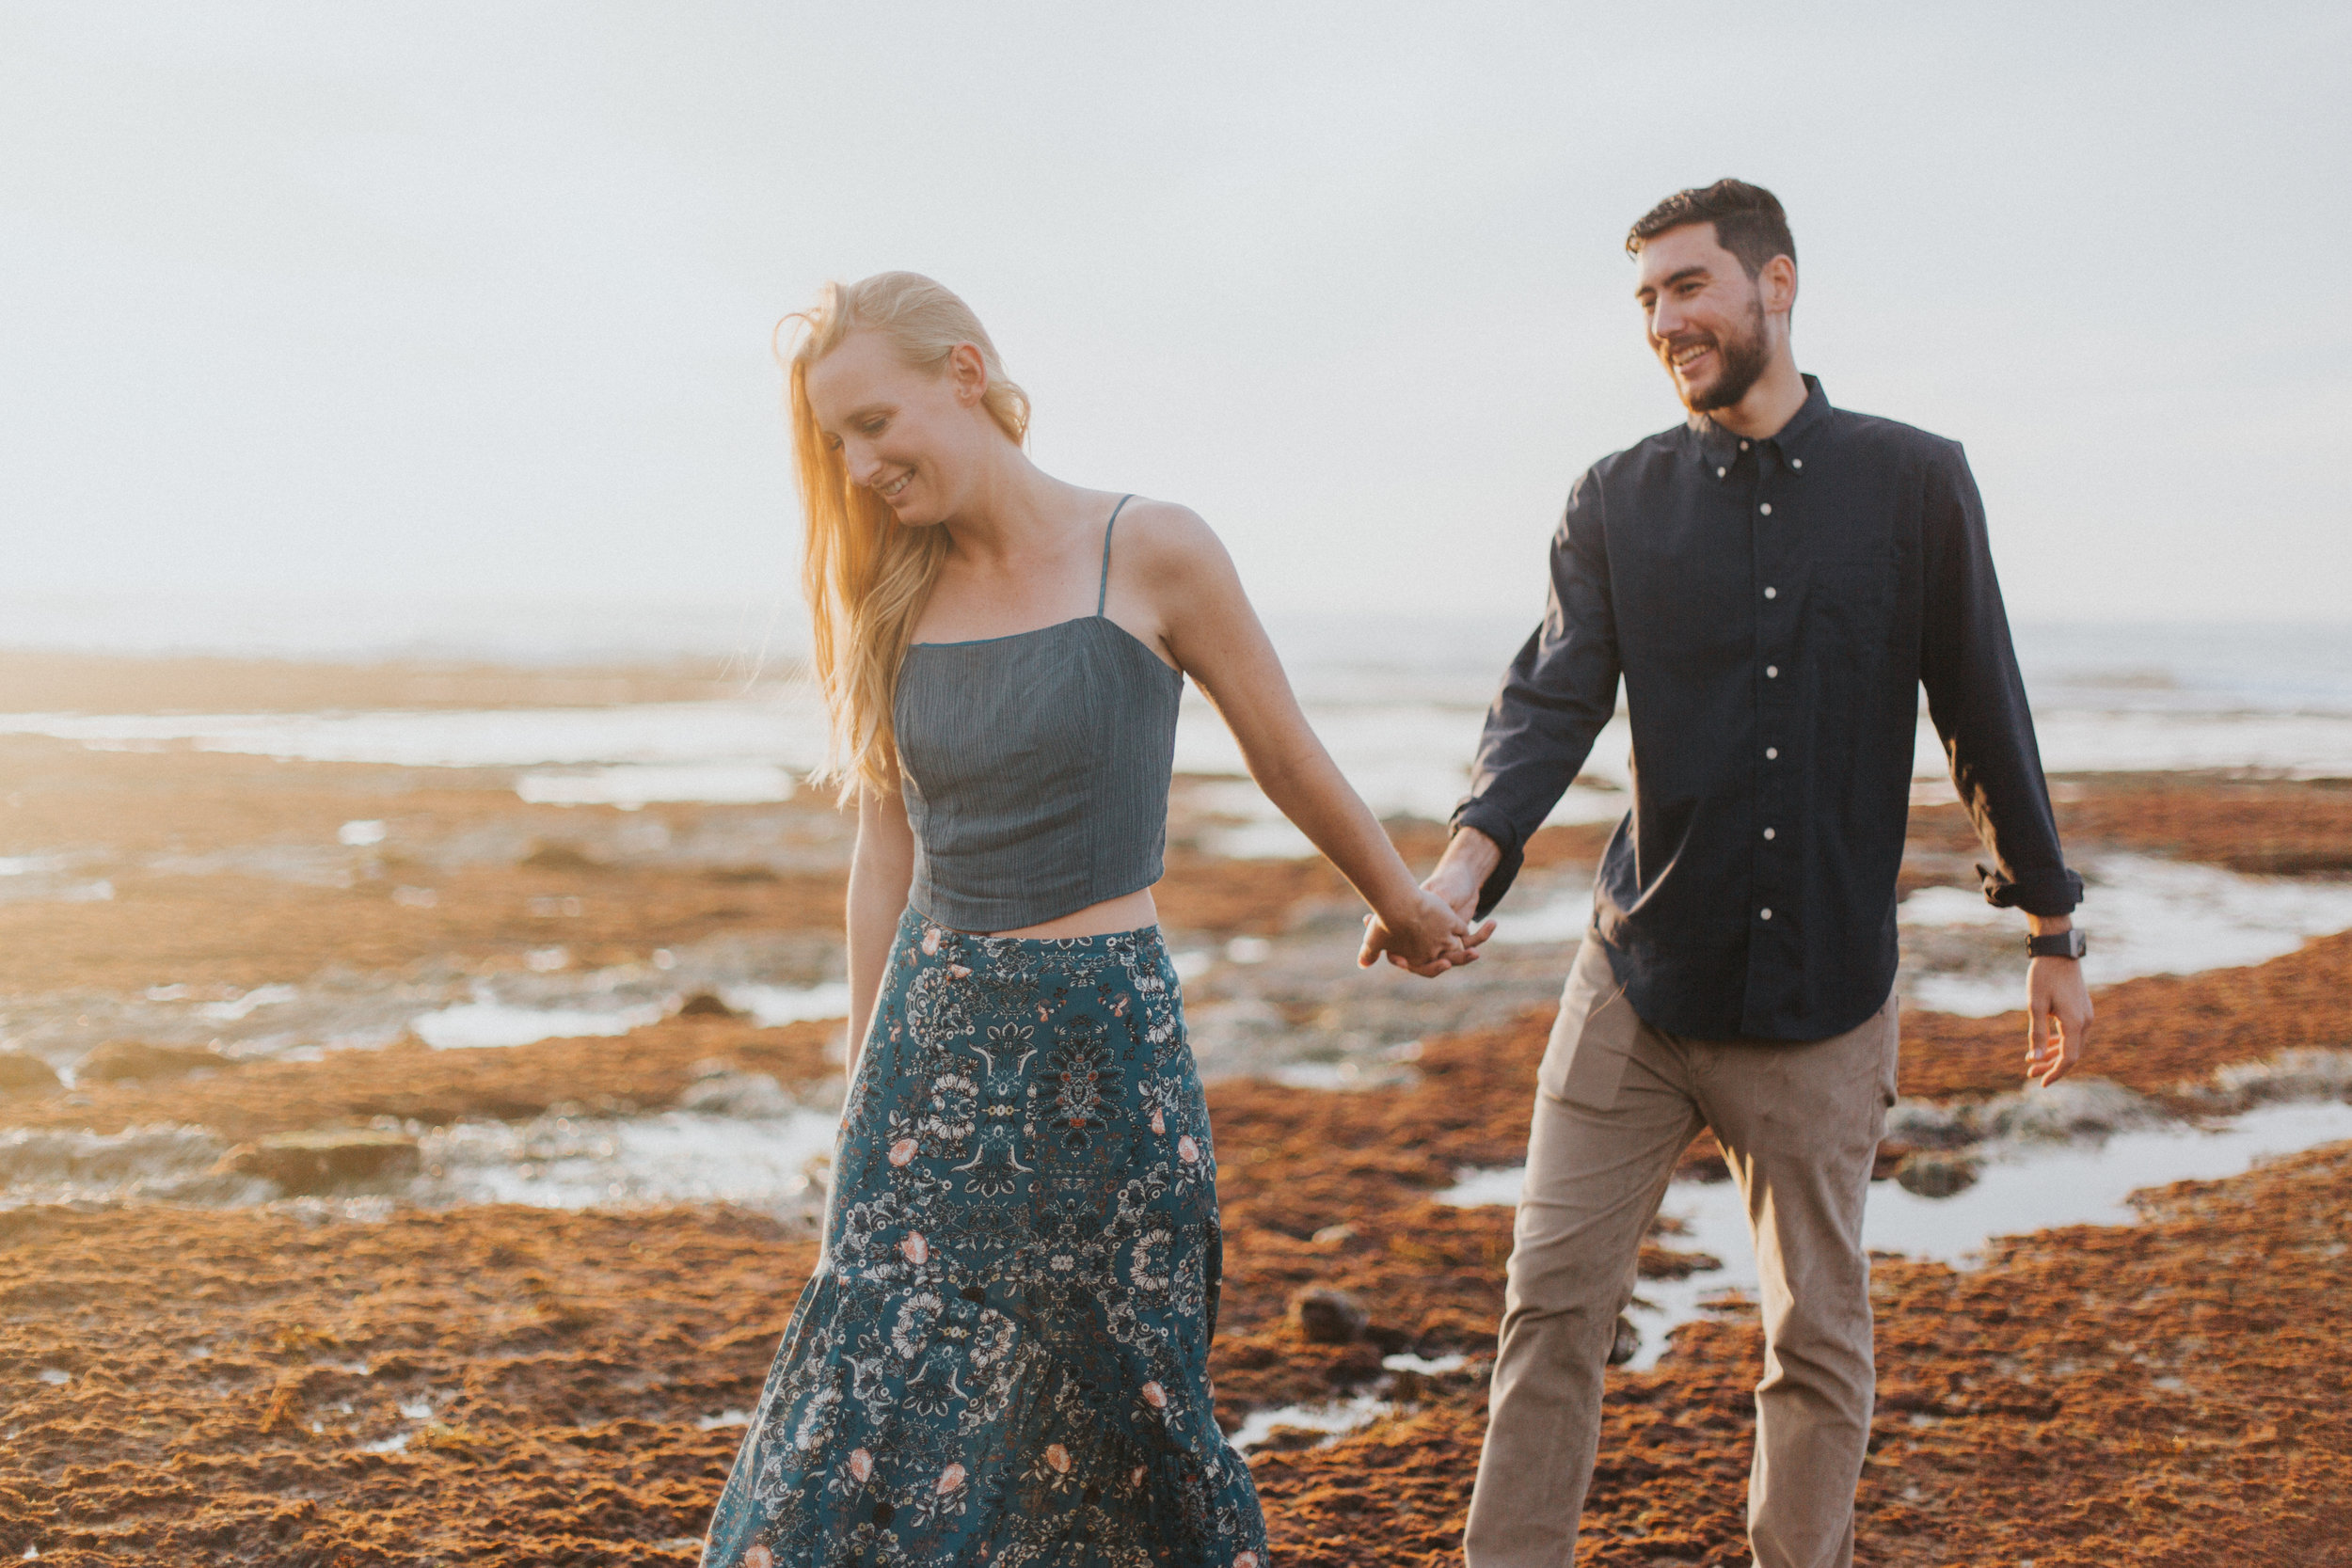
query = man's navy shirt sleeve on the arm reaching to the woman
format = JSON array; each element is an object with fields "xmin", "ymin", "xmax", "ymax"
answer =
[{"xmin": 1454, "ymin": 472, "xmax": 1618, "ymax": 919}]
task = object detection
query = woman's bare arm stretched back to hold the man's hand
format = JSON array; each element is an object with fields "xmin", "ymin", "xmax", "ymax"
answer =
[{"xmin": 1120, "ymin": 505, "xmax": 1485, "ymax": 974}]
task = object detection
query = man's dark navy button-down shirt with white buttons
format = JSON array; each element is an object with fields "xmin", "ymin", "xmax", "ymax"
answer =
[{"xmin": 1454, "ymin": 376, "xmax": 2082, "ymax": 1039}]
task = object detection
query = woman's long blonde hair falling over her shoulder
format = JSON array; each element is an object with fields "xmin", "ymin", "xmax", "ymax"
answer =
[{"xmin": 779, "ymin": 273, "xmax": 1030, "ymax": 801}]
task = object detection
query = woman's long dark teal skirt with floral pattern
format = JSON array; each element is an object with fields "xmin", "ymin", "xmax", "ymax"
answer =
[{"xmin": 704, "ymin": 910, "xmax": 1265, "ymax": 1568}]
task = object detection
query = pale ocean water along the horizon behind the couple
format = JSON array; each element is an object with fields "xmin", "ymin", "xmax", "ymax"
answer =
[{"xmin": 0, "ymin": 599, "xmax": 2352, "ymax": 827}]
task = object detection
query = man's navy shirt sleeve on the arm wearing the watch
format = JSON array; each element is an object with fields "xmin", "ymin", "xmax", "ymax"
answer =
[{"xmin": 1919, "ymin": 442, "xmax": 2082, "ymax": 914}]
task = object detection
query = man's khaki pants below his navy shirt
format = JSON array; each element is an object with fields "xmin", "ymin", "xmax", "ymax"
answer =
[{"xmin": 1463, "ymin": 936, "xmax": 1896, "ymax": 1568}]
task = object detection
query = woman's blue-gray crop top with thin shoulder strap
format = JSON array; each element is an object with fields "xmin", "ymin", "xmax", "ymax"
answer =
[{"xmin": 892, "ymin": 496, "xmax": 1184, "ymax": 931}]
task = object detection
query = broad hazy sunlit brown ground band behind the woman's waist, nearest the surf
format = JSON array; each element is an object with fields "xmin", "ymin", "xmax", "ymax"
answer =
[{"xmin": 0, "ymin": 736, "xmax": 1524, "ymax": 994}]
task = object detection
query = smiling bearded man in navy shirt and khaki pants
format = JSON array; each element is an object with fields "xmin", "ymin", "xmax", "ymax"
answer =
[{"xmin": 1383, "ymin": 179, "xmax": 2091, "ymax": 1568}]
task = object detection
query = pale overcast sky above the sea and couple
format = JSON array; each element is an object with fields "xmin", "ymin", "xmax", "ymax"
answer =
[{"xmin": 0, "ymin": 0, "xmax": 2352, "ymax": 623}]
